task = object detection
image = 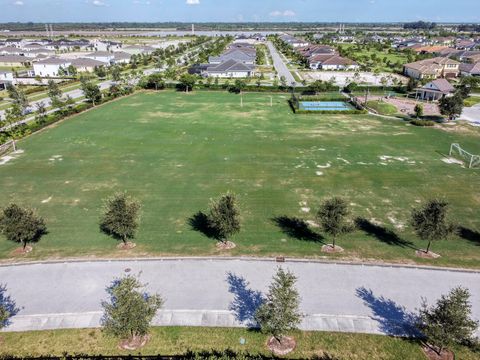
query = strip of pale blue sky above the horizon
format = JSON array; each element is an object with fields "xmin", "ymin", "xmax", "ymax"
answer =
[{"xmin": 0, "ymin": 0, "xmax": 480, "ymax": 23}]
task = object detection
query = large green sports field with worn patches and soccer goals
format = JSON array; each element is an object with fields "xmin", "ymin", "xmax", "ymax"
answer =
[{"xmin": 0, "ymin": 92, "xmax": 480, "ymax": 268}]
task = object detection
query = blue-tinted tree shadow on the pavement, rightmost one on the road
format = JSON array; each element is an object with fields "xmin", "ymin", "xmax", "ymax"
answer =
[{"xmin": 356, "ymin": 287, "xmax": 421, "ymax": 337}]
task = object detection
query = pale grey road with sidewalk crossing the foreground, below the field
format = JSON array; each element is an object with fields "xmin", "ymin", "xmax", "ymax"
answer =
[{"xmin": 0, "ymin": 258, "xmax": 480, "ymax": 335}]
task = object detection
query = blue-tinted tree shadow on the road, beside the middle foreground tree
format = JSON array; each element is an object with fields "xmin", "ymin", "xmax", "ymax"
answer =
[{"xmin": 227, "ymin": 272, "xmax": 264, "ymax": 328}]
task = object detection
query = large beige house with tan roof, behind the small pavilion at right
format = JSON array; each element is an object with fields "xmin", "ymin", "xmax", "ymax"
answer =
[{"xmin": 403, "ymin": 57, "xmax": 460, "ymax": 80}]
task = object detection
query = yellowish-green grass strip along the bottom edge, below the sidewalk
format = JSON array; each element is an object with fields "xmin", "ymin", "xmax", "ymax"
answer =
[{"xmin": 0, "ymin": 327, "xmax": 478, "ymax": 360}]
